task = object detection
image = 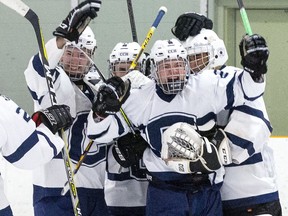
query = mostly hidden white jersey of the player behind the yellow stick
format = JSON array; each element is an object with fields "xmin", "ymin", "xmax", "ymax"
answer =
[{"xmin": 104, "ymin": 70, "xmax": 150, "ymax": 212}]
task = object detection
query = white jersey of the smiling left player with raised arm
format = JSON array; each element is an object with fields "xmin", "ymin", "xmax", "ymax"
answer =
[{"xmin": 25, "ymin": 38, "xmax": 106, "ymax": 202}]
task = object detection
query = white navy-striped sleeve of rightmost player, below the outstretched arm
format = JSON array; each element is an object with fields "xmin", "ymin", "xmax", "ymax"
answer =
[{"xmin": 225, "ymin": 97, "xmax": 272, "ymax": 164}]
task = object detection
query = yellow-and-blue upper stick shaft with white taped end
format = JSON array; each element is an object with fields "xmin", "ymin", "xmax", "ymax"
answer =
[{"xmin": 129, "ymin": 6, "xmax": 167, "ymax": 70}]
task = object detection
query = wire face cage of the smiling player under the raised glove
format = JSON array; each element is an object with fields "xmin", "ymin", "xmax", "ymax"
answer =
[{"xmin": 60, "ymin": 44, "xmax": 94, "ymax": 81}]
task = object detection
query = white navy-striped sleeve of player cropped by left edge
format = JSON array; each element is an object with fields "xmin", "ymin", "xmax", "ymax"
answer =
[{"xmin": 0, "ymin": 96, "xmax": 64, "ymax": 169}]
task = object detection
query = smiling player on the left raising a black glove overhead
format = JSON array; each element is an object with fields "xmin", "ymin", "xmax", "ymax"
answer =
[{"xmin": 25, "ymin": 0, "xmax": 107, "ymax": 216}]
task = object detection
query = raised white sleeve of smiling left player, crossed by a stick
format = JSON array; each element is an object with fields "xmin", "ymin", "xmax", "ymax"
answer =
[{"xmin": 24, "ymin": 38, "xmax": 76, "ymax": 116}]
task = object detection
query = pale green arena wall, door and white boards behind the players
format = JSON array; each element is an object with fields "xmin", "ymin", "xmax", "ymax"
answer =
[{"xmin": 0, "ymin": 0, "xmax": 288, "ymax": 216}]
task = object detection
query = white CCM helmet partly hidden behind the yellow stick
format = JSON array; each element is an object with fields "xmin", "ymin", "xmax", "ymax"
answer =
[{"xmin": 108, "ymin": 42, "xmax": 146, "ymax": 76}]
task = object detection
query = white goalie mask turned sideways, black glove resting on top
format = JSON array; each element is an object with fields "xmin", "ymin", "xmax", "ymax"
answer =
[{"xmin": 183, "ymin": 29, "xmax": 228, "ymax": 73}]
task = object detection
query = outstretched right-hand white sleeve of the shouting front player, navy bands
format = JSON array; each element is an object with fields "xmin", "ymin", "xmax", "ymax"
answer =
[{"xmin": 198, "ymin": 67, "xmax": 265, "ymax": 112}]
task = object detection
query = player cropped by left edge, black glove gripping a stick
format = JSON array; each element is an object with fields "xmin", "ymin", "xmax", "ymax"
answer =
[{"xmin": 0, "ymin": 95, "xmax": 72, "ymax": 216}]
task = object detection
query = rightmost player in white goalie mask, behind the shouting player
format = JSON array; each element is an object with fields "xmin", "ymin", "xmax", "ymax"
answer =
[{"xmin": 173, "ymin": 14, "xmax": 281, "ymax": 216}]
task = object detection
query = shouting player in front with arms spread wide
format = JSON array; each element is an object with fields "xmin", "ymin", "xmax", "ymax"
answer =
[{"xmin": 88, "ymin": 34, "xmax": 265, "ymax": 216}]
